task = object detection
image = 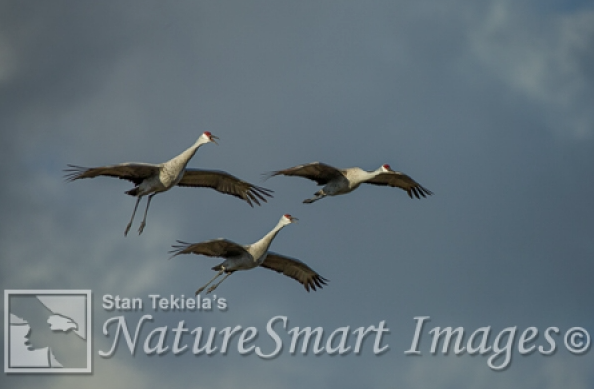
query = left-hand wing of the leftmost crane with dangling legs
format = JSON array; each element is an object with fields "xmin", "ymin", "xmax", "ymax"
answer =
[{"xmin": 64, "ymin": 162, "xmax": 161, "ymax": 185}]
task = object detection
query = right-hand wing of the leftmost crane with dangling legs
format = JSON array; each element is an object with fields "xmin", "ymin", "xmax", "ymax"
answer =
[{"xmin": 177, "ymin": 169, "xmax": 273, "ymax": 207}]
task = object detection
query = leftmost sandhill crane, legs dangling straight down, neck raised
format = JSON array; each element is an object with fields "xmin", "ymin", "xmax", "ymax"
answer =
[{"xmin": 65, "ymin": 131, "xmax": 272, "ymax": 235}]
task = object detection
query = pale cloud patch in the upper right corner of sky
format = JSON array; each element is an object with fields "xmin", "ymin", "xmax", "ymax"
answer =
[{"xmin": 470, "ymin": 0, "xmax": 594, "ymax": 138}]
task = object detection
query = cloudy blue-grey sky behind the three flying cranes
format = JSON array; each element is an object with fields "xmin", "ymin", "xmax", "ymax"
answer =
[{"xmin": 0, "ymin": 0, "xmax": 594, "ymax": 389}]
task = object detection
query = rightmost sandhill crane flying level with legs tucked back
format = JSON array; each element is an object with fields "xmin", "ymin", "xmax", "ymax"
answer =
[{"xmin": 267, "ymin": 162, "xmax": 433, "ymax": 204}]
